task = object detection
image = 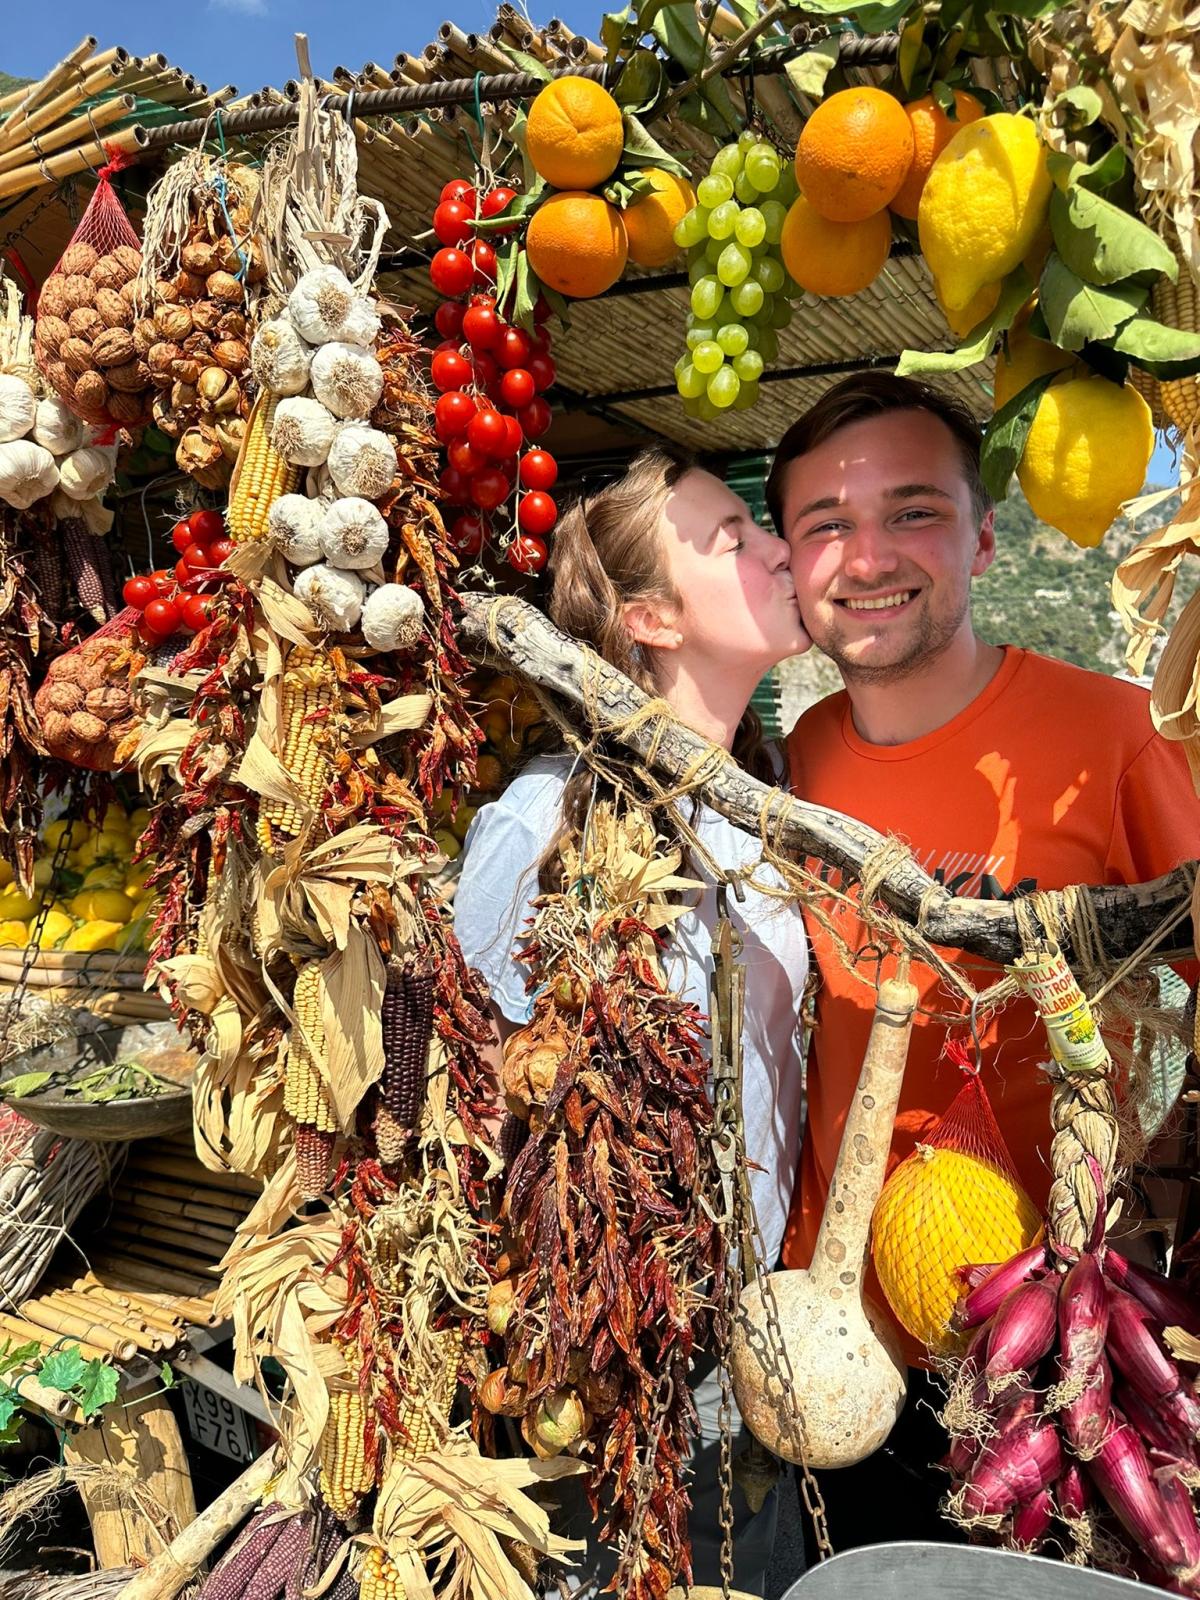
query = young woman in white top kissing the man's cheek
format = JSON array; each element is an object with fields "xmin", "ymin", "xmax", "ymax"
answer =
[{"xmin": 454, "ymin": 451, "xmax": 810, "ymax": 1594}]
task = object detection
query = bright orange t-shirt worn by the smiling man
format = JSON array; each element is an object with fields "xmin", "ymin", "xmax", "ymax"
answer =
[{"xmin": 784, "ymin": 645, "xmax": 1200, "ymax": 1350}]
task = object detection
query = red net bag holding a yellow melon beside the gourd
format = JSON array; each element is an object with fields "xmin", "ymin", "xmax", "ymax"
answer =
[{"xmin": 872, "ymin": 1042, "xmax": 1042, "ymax": 1354}]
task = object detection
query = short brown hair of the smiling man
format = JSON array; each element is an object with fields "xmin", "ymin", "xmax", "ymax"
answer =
[{"xmin": 766, "ymin": 373, "xmax": 992, "ymax": 534}]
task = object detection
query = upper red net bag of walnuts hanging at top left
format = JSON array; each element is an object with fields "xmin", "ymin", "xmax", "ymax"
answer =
[{"xmin": 35, "ymin": 155, "xmax": 154, "ymax": 430}]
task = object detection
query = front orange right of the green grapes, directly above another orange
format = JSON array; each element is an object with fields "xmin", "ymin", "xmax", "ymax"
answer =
[{"xmin": 795, "ymin": 88, "xmax": 914, "ymax": 222}]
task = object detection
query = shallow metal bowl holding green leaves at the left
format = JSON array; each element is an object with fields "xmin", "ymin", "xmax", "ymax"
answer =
[{"xmin": 0, "ymin": 1022, "xmax": 198, "ymax": 1142}]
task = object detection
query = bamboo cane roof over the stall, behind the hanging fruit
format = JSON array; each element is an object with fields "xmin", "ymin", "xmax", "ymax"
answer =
[{"xmin": 0, "ymin": 5, "xmax": 1006, "ymax": 453}]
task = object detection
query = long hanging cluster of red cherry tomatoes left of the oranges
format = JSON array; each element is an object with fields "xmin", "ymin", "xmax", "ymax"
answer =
[{"xmin": 429, "ymin": 178, "xmax": 558, "ymax": 573}]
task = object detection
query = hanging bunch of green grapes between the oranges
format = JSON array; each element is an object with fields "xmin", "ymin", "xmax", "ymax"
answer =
[{"xmin": 675, "ymin": 130, "xmax": 802, "ymax": 422}]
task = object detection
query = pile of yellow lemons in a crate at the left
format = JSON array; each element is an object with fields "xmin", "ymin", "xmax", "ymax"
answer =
[{"xmin": 0, "ymin": 802, "xmax": 155, "ymax": 968}]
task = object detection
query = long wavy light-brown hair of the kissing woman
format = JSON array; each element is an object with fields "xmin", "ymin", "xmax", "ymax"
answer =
[{"xmin": 542, "ymin": 448, "xmax": 776, "ymax": 877}]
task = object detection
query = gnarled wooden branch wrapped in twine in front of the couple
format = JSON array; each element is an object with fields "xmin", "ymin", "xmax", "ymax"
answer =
[{"xmin": 459, "ymin": 595, "xmax": 1192, "ymax": 963}]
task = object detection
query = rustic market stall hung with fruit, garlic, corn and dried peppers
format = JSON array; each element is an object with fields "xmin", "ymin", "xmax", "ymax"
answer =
[{"xmin": 0, "ymin": 0, "xmax": 1200, "ymax": 1600}]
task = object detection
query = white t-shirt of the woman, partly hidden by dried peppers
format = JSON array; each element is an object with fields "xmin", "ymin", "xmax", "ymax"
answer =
[{"xmin": 454, "ymin": 755, "xmax": 808, "ymax": 1266}]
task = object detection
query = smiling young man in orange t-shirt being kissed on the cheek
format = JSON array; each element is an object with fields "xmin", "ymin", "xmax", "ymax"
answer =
[{"xmin": 766, "ymin": 373, "xmax": 1200, "ymax": 1549}]
